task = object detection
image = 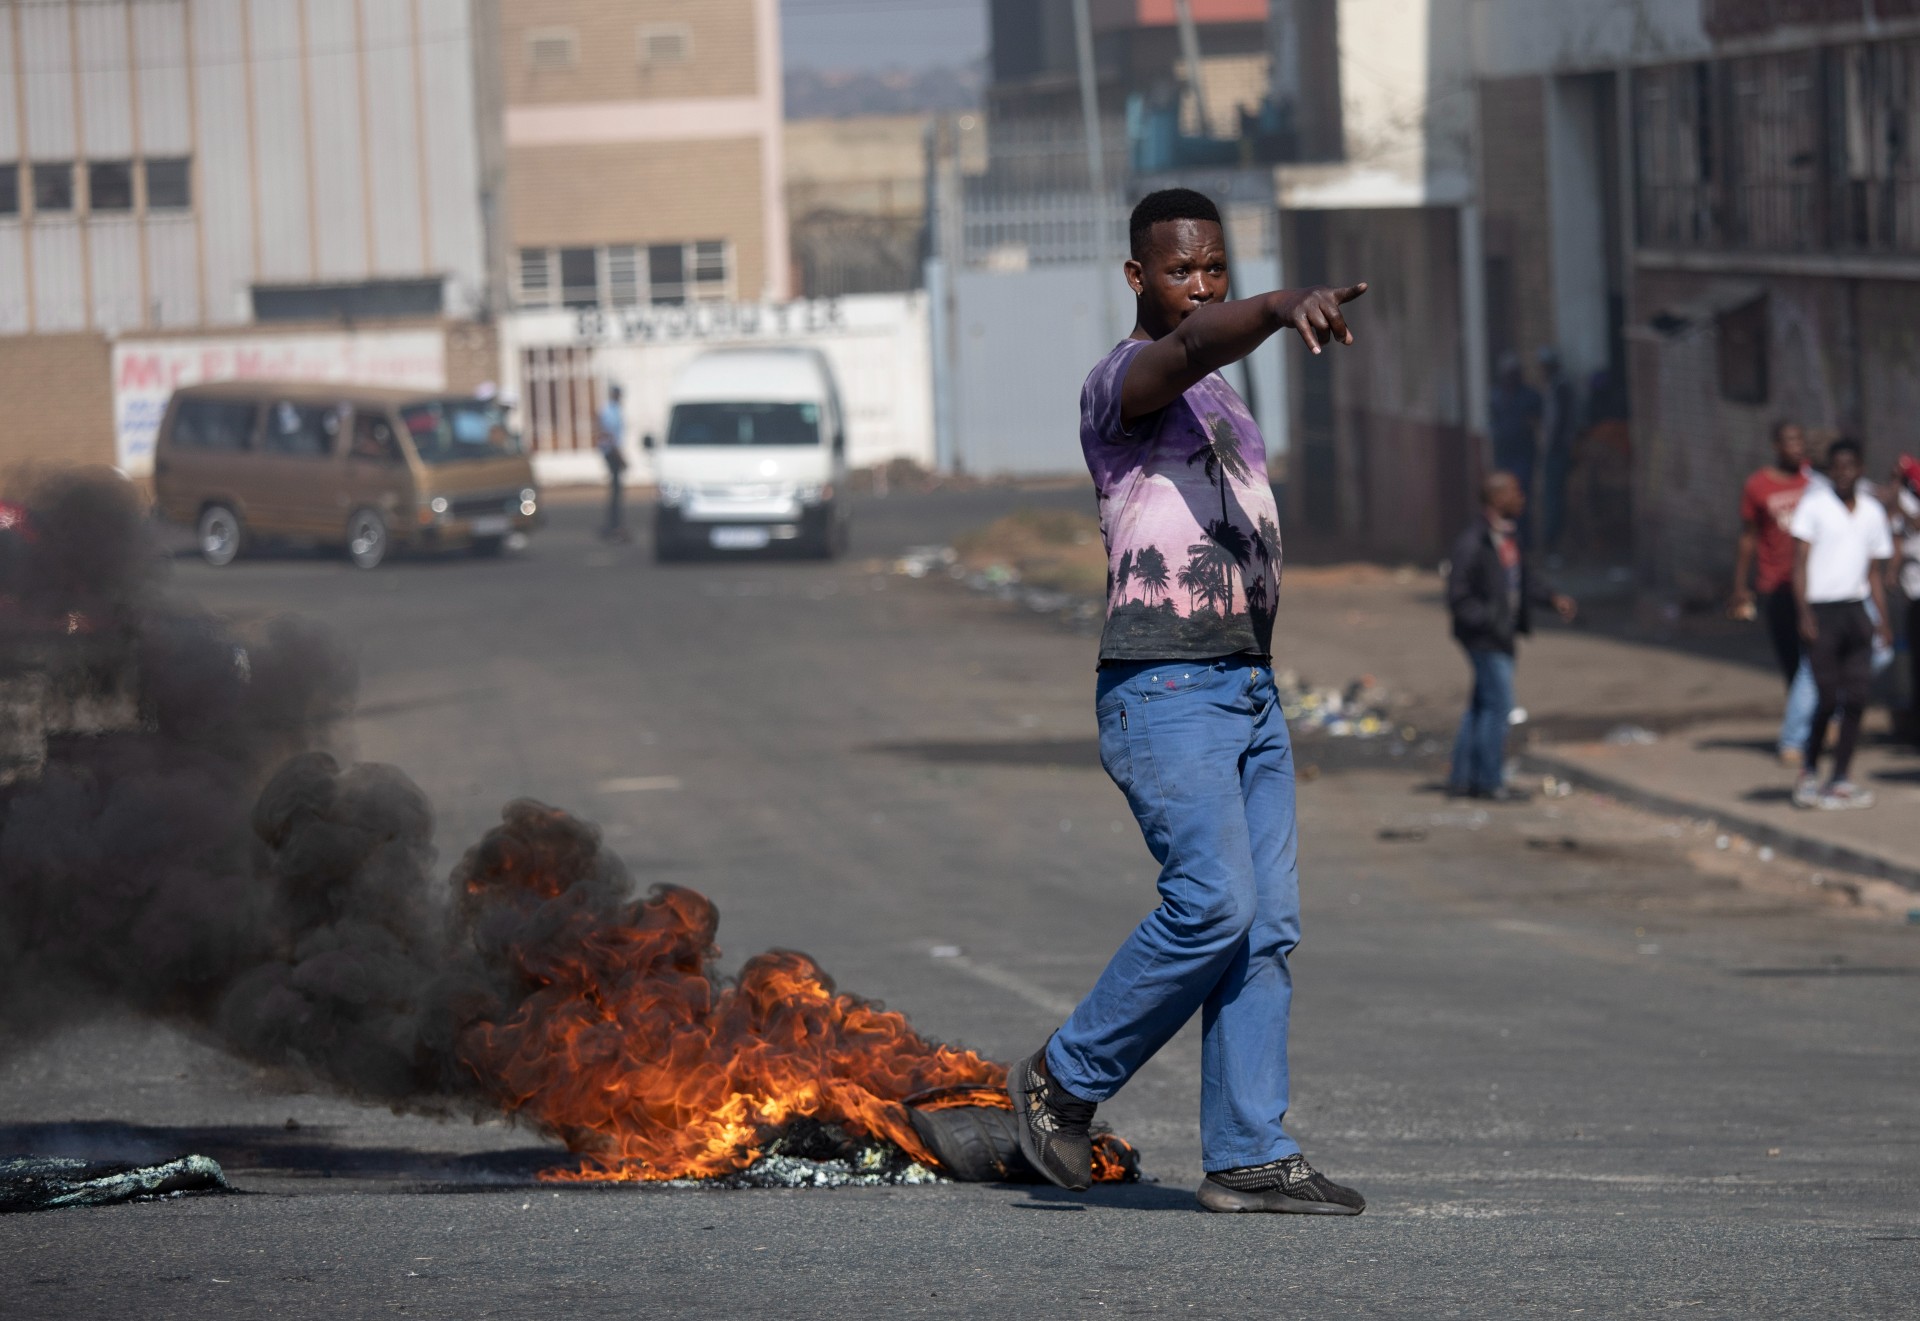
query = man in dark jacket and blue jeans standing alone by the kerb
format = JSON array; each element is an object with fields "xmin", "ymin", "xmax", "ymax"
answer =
[{"xmin": 1446, "ymin": 472, "xmax": 1576, "ymax": 803}]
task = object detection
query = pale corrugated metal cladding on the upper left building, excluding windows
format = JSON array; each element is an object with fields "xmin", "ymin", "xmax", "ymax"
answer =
[{"xmin": 0, "ymin": 0, "xmax": 486, "ymax": 334}]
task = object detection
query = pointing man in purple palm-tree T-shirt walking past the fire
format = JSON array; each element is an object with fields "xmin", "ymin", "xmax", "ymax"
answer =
[{"xmin": 1006, "ymin": 188, "xmax": 1367, "ymax": 1215}]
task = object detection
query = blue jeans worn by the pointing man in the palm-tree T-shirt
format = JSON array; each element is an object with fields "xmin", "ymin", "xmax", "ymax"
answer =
[{"xmin": 1046, "ymin": 657, "xmax": 1300, "ymax": 1173}]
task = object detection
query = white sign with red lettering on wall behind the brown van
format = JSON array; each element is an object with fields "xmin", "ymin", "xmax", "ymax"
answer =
[{"xmin": 113, "ymin": 330, "xmax": 447, "ymax": 476}]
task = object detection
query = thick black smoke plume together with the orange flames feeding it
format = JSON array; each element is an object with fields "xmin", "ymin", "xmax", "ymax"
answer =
[{"xmin": 0, "ymin": 476, "xmax": 1067, "ymax": 1179}]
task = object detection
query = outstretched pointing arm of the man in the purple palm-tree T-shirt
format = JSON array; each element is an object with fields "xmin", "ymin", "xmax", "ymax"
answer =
[{"xmin": 1119, "ymin": 282, "xmax": 1367, "ymax": 424}]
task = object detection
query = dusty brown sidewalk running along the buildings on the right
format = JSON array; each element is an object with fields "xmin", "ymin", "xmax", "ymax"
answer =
[{"xmin": 1275, "ymin": 566, "xmax": 1920, "ymax": 889}]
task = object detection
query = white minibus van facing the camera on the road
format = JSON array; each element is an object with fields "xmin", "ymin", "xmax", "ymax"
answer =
[{"xmin": 641, "ymin": 348, "xmax": 847, "ymax": 559}]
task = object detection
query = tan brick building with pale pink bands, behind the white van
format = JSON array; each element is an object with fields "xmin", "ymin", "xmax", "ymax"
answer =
[{"xmin": 499, "ymin": 0, "xmax": 791, "ymax": 309}]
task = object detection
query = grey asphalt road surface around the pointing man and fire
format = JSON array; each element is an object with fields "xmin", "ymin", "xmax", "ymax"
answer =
[{"xmin": 0, "ymin": 490, "xmax": 1920, "ymax": 1317}]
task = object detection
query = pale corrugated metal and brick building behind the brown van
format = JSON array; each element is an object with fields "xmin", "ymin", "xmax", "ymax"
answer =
[{"xmin": 0, "ymin": 0, "xmax": 497, "ymax": 472}]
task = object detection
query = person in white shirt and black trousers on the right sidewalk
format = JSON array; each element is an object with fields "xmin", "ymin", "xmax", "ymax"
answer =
[{"xmin": 1788, "ymin": 438, "xmax": 1893, "ymax": 808}]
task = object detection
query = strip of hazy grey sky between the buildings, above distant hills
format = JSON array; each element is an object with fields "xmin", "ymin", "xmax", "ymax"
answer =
[{"xmin": 780, "ymin": 0, "xmax": 987, "ymax": 71}]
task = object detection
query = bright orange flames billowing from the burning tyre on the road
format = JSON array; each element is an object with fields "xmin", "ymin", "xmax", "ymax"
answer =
[{"xmin": 459, "ymin": 805, "xmax": 1131, "ymax": 1181}]
